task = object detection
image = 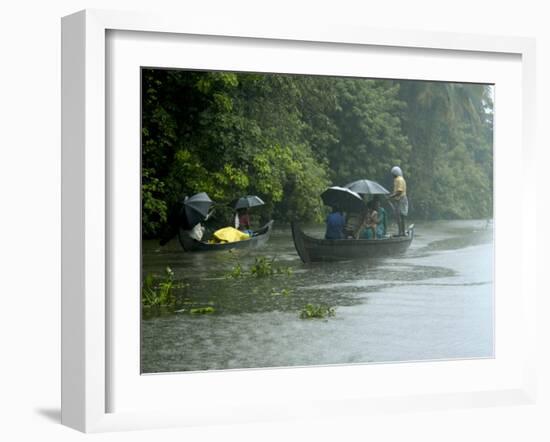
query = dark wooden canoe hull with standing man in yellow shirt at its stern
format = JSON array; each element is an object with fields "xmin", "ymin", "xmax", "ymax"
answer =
[{"xmin": 291, "ymin": 223, "xmax": 414, "ymax": 263}]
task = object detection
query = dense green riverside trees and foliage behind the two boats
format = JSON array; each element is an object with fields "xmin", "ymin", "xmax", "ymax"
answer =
[{"xmin": 142, "ymin": 69, "xmax": 492, "ymax": 237}]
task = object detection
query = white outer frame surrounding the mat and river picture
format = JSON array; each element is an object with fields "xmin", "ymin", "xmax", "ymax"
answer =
[{"xmin": 62, "ymin": 10, "xmax": 537, "ymax": 432}]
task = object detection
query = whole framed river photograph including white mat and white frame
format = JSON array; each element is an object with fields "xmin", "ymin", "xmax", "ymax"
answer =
[{"xmin": 62, "ymin": 11, "xmax": 536, "ymax": 432}]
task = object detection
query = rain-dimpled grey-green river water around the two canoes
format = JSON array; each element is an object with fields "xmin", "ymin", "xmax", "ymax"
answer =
[{"xmin": 141, "ymin": 220, "xmax": 494, "ymax": 373}]
